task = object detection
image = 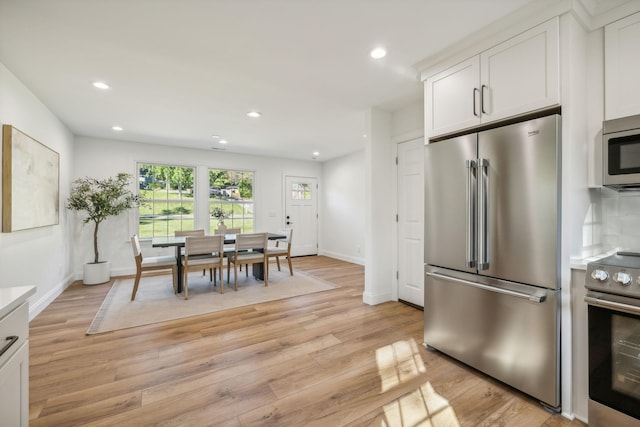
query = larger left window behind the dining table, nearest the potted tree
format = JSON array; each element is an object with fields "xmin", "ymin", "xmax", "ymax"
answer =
[{"xmin": 138, "ymin": 164, "xmax": 195, "ymax": 238}]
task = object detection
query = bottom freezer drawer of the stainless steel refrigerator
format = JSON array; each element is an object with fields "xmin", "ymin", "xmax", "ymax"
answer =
[{"xmin": 424, "ymin": 267, "xmax": 560, "ymax": 408}]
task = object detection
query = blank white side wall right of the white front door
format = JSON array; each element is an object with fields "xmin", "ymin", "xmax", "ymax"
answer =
[{"xmin": 320, "ymin": 150, "xmax": 367, "ymax": 264}]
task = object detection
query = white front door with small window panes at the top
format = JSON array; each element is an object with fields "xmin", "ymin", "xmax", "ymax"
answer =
[{"xmin": 285, "ymin": 176, "xmax": 318, "ymax": 256}]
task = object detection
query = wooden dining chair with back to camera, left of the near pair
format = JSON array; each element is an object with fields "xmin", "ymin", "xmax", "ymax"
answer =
[{"xmin": 182, "ymin": 235, "xmax": 224, "ymax": 299}]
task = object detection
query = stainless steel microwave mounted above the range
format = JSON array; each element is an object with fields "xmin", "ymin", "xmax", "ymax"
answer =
[{"xmin": 602, "ymin": 114, "xmax": 640, "ymax": 191}]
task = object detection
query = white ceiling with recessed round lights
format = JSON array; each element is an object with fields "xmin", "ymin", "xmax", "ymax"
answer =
[{"xmin": 0, "ymin": 0, "xmax": 536, "ymax": 161}]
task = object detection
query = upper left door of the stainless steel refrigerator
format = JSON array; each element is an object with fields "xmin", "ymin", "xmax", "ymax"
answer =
[{"xmin": 424, "ymin": 134, "xmax": 477, "ymax": 272}]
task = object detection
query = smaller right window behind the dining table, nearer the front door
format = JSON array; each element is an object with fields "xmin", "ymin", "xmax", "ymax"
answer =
[{"xmin": 209, "ymin": 169, "xmax": 254, "ymax": 234}]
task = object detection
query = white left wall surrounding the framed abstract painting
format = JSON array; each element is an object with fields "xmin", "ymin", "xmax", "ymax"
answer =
[{"xmin": 0, "ymin": 64, "xmax": 74, "ymax": 318}]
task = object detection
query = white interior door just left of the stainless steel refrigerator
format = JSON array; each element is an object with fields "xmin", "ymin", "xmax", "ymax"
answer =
[{"xmin": 398, "ymin": 138, "xmax": 424, "ymax": 307}]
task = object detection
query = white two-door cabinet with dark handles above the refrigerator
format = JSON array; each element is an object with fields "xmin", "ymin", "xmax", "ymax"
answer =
[{"xmin": 425, "ymin": 18, "xmax": 560, "ymax": 136}]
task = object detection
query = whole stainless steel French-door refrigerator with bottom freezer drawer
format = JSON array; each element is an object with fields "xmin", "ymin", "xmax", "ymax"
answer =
[{"xmin": 424, "ymin": 115, "xmax": 561, "ymax": 410}]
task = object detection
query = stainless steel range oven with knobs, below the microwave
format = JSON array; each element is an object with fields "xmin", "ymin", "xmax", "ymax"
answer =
[{"xmin": 585, "ymin": 252, "xmax": 640, "ymax": 427}]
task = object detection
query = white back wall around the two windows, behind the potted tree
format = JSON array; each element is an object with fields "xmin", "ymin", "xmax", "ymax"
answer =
[{"xmin": 72, "ymin": 137, "xmax": 322, "ymax": 279}]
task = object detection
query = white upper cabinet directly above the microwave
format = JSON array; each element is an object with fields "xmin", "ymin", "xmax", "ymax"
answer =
[{"xmin": 604, "ymin": 13, "xmax": 640, "ymax": 120}]
